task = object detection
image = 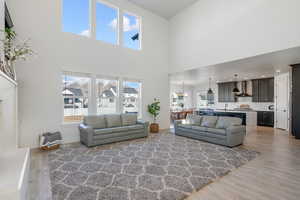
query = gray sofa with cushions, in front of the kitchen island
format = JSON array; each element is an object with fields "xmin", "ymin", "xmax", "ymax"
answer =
[{"xmin": 174, "ymin": 115, "xmax": 246, "ymax": 147}]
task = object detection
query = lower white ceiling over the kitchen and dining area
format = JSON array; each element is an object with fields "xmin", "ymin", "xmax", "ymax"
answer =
[{"xmin": 170, "ymin": 47, "xmax": 300, "ymax": 86}]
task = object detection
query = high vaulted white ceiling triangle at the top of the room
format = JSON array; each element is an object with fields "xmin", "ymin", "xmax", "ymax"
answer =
[{"xmin": 128, "ymin": 0, "xmax": 197, "ymax": 19}]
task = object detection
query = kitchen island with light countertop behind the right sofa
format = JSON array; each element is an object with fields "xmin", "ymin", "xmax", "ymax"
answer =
[{"xmin": 196, "ymin": 109, "xmax": 257, "ymax": 126}]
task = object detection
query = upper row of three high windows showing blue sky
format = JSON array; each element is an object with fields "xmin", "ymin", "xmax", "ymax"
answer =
[{"xmin": 62, "ymin": 0, "xmax": 141, "ymax": 50}]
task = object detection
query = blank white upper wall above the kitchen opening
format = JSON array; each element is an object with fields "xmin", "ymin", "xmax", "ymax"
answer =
[{"xmin": 170, "ymin": 0, "xmax": 300, "ymax": 72}]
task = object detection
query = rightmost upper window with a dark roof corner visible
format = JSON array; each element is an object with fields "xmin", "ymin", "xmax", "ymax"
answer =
[{"xmin": 123, "ymin": 13, "xmax": 141, "ymax": 50}]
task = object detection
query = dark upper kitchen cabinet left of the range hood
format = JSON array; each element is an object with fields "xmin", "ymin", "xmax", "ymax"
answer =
[{"xmin": 218, "ymin": 82, "xmax": 236, "ymax": 103}]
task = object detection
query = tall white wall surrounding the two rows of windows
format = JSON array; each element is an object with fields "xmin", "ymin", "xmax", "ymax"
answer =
[{"xmin": 7, "ymin": 0, "xmax": 169, "ymax": 147}]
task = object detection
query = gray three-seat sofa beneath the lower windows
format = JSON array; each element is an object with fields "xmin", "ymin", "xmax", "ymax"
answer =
[{"xmin": 79, "ymin": 114, "xmax": 149, "ymax": 147}]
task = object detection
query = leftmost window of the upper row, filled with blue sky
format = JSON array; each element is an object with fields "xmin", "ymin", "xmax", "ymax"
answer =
[{"xmin": 62, "ymin": 0, "xmax": 90, "ymax": 37}]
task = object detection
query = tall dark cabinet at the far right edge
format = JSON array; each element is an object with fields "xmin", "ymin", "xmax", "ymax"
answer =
[{"xmin": 292, "ymin": 64, "xmax": 300, "ymax": 139}]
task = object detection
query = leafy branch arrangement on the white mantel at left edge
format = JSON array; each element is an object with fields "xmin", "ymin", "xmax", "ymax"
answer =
[{"xmin": 1, "ymin": 28, "xmax": 34, "ymax": 80}]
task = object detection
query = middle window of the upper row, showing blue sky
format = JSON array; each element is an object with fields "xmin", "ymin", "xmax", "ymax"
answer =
[{"xmin": 96, "ymin": 2, "xmax": 119, "ymax": 44}]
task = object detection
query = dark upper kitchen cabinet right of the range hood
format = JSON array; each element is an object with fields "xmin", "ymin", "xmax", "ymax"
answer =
[{"xmin": 252, "ymin": 78, "xmax": 274, "ymax": 102}]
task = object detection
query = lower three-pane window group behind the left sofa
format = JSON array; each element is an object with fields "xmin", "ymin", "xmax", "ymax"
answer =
[{"xmin": 61, "ymin": 72, "xmax": 142, "ymax": 123}]
